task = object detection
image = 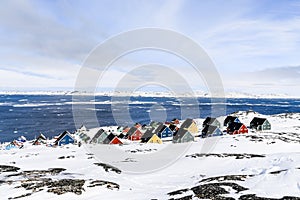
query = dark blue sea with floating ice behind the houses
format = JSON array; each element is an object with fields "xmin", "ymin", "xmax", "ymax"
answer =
[{"xmin": 0, "ymin": 95, "xmax": 300, "ymax": 142}]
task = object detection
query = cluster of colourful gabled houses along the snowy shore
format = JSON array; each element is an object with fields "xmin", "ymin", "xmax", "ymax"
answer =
[{"xmin": 5, "ymin": 115, "xmax": 271, "ymax": 150}]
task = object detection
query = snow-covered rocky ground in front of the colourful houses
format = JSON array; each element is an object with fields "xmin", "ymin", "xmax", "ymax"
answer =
[{"xmin": 0, "ymin": 112, "xmax": 300, "ymax": 200}]
